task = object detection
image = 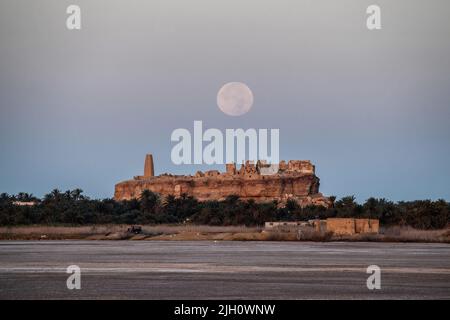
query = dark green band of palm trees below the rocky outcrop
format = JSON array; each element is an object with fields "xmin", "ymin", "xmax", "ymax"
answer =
[{"xmin": 0, "ymin": 189, "xmax": 450, "ymax": 229}]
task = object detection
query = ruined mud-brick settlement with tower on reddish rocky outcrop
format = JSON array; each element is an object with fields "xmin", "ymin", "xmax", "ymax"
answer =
[{"xmin": 114, "ymin": 154, "xmax": 330, "ymax": 207}]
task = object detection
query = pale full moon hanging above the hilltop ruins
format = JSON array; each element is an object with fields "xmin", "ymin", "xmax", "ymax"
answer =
[{"xmin": 217, "ymin": 82, "xmax": 253, "ymax": 116}]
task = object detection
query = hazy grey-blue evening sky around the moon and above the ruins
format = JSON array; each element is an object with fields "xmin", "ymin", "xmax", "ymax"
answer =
[{"xmin": 0, "ymin": 0, "xmax": 450, "ymax": 201}]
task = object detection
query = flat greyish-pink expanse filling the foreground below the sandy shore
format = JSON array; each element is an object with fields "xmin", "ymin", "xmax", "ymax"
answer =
[{"xmin": 0, "ymin": 240, "xmax": 450, "ymax": 299}]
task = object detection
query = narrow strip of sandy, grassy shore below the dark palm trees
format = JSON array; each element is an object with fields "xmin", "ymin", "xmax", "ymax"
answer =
[{"xmin": 0, "ymin": 224, "xmax": 450, "ymax": 243}]
